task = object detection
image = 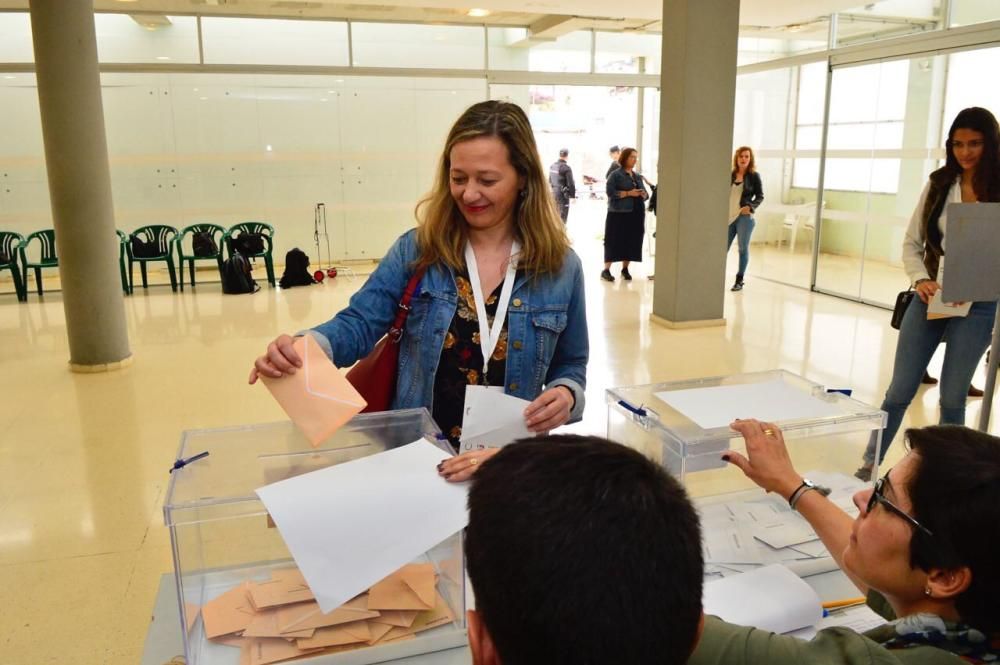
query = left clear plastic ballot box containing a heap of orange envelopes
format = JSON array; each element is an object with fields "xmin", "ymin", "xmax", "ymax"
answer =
[{"xmin": 163, "ymin": 409, "xmax": 467, "ymax": 665}]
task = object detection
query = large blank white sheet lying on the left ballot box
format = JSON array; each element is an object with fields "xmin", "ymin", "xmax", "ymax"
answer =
[{"xmin": 257, "ymin": 439, "xmax": 468, "ymax": 612}]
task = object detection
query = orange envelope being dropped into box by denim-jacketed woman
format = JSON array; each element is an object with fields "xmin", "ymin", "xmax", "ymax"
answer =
[{"xmin": 261, "ymin": 335, "xmax": 368, "ymax": 448}]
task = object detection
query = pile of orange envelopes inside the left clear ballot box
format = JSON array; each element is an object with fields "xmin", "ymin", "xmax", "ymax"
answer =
[{"xmin": 189, "ymin": 563, "xmax": 454, "ymax": 665}]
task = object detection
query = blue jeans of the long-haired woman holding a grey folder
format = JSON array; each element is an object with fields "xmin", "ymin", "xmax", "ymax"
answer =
[{"xmin": 864, "ymin": 298, "xmax": 996, "ymax": 464}]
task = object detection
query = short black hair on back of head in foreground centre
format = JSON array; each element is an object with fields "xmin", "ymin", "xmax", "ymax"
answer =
[{"xmin": 465, "ymin": 435, "xmax": 703, "ymax": 665}]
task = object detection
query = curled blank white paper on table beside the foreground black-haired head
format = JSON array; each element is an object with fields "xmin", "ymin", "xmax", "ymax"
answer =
[{"xmin": 702, "ymin": 565, "xmax": 823, "ymax": 633}]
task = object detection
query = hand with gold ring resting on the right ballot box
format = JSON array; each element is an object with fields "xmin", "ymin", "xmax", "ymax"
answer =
[{"xmin": 722, "ymin": 418, "xmax": 802, "ymax": 499}]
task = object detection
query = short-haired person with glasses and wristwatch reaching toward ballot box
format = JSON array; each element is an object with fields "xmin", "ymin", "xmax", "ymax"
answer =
[{"xmin": 689, "ymin": 420, "xmax": 1000, "ymax": 665}]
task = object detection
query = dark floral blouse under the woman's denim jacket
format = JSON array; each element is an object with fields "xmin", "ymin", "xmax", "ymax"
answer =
[{"xmin": 432, "ymin": 269, "xmax": 520, "ymax": 450}]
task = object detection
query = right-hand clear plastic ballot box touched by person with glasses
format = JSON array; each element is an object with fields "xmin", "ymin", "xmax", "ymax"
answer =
[{"xmin": 606, "ymin": 370, "xmax": 885, "ymax": 497}]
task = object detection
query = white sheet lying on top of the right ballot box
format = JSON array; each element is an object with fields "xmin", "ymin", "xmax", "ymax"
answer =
[{"xmin": 655, "ymin": 379, "xmax": 843, "ymax": 429}]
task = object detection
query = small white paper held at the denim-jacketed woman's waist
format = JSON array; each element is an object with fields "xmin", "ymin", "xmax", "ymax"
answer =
[{"xmin": 462, "ymin": 386, "xmax": 534, "ymax": 452}]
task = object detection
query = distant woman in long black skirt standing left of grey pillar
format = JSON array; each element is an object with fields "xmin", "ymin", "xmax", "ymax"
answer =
[{"xmin": 601, "ymin": 148, "xmax": 649, "ymax": 282}]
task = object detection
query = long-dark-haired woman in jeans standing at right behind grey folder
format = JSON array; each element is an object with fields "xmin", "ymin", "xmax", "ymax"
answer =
[{"xmin": 855, "ymin": 107, "xmax": 1000, "ymax": 480}]
